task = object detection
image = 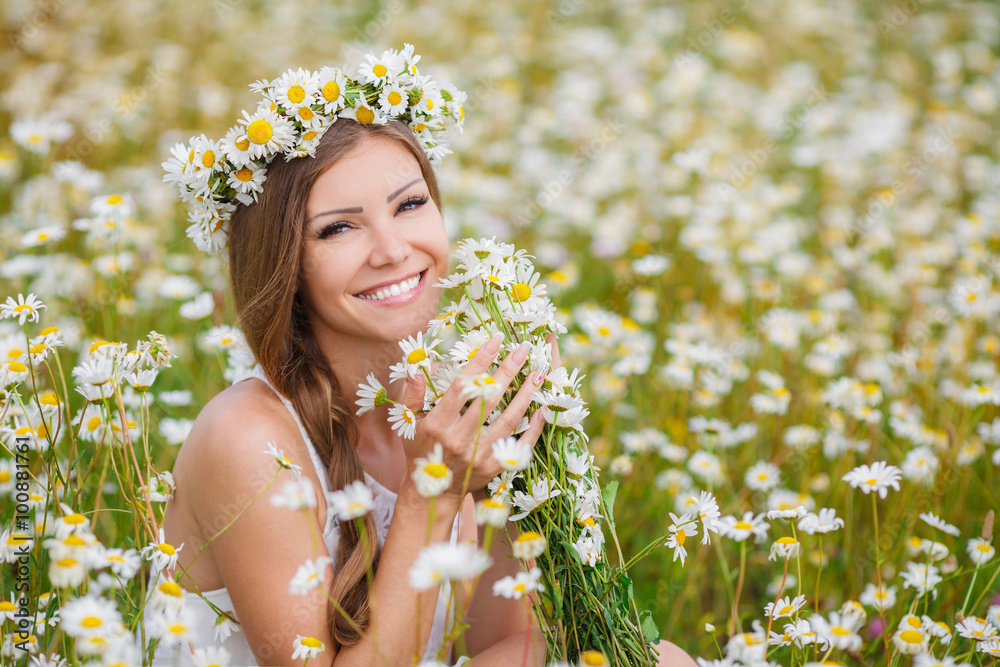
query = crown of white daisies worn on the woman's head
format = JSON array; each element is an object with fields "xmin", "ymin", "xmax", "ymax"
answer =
[{"xmin": 163, "ymin": 44, "xmax": 466, "ymax": 254}]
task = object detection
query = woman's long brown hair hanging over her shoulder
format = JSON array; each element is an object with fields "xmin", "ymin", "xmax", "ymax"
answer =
[{"xmin": 229, "ymin": 119, "xmax": 441, "ymax": 645}]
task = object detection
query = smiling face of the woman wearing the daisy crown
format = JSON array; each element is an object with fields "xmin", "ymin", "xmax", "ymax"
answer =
[{"xmin": 299, "ymin": 138, "xmax": 448, "ymax": 355}]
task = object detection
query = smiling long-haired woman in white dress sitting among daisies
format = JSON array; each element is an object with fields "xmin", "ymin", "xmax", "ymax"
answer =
[{"xmin": 154, "ymin": 68, "xmax": 693, "ymax": 665}]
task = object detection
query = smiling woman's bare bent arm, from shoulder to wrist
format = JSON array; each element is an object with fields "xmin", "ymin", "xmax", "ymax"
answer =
[{"xmin": 179, "ymin": 400, "xmax": 458, "ymax": 665}]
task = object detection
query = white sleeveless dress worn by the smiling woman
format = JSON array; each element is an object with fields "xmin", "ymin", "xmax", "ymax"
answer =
[{"xmin": 145, "ymin": 366, "xmax": 461, "ymax": 667}]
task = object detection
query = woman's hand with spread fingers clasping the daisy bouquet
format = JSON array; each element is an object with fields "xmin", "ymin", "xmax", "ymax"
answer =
[{"xmin": 403, "ymin": 334, "xmax": 548, "ymax": 500}]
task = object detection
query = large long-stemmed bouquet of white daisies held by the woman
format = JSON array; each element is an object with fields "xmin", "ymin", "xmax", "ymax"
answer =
[{"xmin": 358, "ymin": 239, "xmax": 697, "ymax": 665}]
